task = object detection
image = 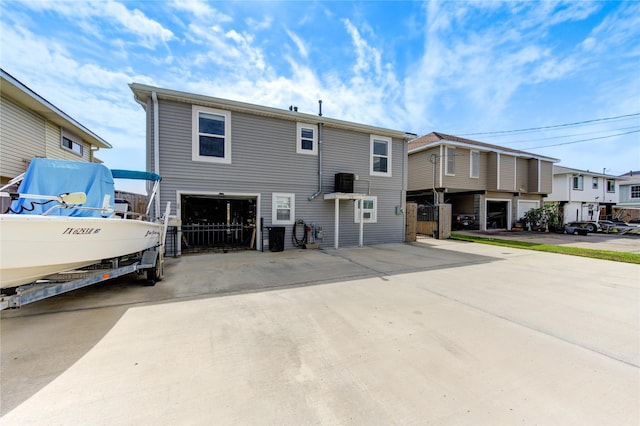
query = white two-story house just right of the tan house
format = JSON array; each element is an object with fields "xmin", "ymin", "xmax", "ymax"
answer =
[{"xmin": 547, "ymin": 165, "xmax": 621, "ymax": 223}]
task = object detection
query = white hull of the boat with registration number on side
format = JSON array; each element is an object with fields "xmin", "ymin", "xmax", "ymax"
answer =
[{"xmin": 0, "ymin": 214, "xmax": 162, "ymax": 288}]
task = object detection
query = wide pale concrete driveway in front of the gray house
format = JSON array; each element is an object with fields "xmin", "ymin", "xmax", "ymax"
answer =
[{"xmin": 1, "ymin": 240, "xmax": 640, "ymax": 425}]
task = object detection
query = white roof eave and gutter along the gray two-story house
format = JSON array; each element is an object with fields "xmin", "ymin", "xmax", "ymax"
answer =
[{"xmin": 129, "ymin": 83, "xmax": 416, "ymax": 141}]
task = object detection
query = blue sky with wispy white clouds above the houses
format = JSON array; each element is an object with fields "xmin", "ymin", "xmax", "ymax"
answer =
[{"xmin": 0, "ymin": 0, "xmax": 640, "ymax": 190}]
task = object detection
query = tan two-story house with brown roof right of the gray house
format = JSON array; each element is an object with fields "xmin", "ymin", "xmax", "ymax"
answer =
[{"xmin": 407, "ymin": 132, "xmax": 558, "ymax": 230}]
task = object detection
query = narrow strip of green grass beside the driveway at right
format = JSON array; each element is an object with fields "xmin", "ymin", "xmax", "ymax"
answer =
[{"xmin": 451, "ymin": 233, "xmax": 640, "ymax": 265}]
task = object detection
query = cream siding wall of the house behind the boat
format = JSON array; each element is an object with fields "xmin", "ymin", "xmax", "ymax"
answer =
[{"xmin": 0, "ymin": 95, "xmax": 91, "ymax": 180}]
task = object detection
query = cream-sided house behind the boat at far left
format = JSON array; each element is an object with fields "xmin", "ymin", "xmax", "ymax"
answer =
[{"xmin": 0, "ymin": 69, "xmax": 111, "ymax": 184}]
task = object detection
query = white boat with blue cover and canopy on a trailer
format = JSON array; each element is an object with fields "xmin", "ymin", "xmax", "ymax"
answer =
[{"xmin": 0, "ymin": 159, "xmax": 166, "ymax": 289}]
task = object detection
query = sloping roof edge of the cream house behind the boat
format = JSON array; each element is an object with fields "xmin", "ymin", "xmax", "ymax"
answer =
[{"xmin": 0, "ymin": 68, "xmax": 113, "ymax": 149}]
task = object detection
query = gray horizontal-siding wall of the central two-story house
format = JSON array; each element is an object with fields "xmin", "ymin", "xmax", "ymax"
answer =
[{"xmin": 152, "ymin": 99, "xmax": 406, "ymax": 248}]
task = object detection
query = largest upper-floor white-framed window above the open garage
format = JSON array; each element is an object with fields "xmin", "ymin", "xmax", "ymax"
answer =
[{"xmin": 191, "ymin": 105, "xmax": 231, "ymax": 164}]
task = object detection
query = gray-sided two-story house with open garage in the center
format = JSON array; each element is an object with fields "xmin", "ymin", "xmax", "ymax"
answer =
[{"xmin": 130, "ymin": 83, "xmax": 415, "ymax": 250}]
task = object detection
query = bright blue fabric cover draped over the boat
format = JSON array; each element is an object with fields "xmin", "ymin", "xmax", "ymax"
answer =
[{"xmin": 11, "ymin": 158, "xmax": 114, "ymax": 217}]
